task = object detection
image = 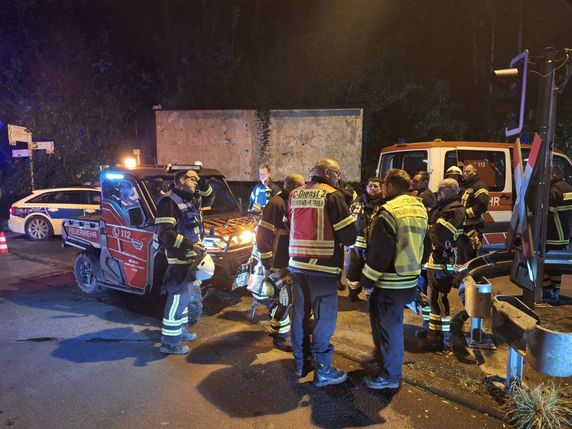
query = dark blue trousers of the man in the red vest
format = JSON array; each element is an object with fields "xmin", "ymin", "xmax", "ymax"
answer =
[{"xmin": 291, "ymin": 271, "xmax": 338, "ymax": 366}]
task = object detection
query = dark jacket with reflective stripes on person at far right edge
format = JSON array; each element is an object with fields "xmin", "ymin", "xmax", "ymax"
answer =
[{"xmin": 546, "ymin": 179, "xmax": 572, "ymax": 246}]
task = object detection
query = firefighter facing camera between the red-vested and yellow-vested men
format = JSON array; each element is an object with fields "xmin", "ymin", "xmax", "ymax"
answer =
[{"xmin": 345, "ymin": 177, "xmax": 384, "ymax": 302}]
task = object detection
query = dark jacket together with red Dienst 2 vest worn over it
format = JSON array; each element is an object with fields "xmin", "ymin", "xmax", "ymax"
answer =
[{"xmin": 288, "ymin": 177, "xmax": 357, "ymax": 275}]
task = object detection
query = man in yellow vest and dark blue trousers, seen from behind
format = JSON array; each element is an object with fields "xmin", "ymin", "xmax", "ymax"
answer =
[{"xmin": 361, "ymin": 169, "xmax": 427, "ymax": 389}]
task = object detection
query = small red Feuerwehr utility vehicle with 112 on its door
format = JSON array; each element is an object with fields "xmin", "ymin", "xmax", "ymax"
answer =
[{"xmin": 62, "ymin": 165, "xmax": 256, "ymax": 295}]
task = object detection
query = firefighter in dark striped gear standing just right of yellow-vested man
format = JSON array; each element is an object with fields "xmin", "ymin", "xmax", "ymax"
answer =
[{"xmin": 416, "ymin": 179, "xmax": 465, "ymax": 351}]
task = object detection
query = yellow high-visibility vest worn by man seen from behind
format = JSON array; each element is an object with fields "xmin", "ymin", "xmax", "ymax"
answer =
[{"xmin": 364, "ymin": 195, "xmax": 428, "ymax": 289}]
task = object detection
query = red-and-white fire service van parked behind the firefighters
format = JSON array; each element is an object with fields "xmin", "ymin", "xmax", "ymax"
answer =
[{"xmin": 377, "ymin": 139, "xmax": 572, "ymax": 250}]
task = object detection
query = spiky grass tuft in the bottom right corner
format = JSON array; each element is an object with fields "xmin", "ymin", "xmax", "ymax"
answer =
[{"xmin": 503, "ymin": 382, "xmax": 572, "ymax": 429}]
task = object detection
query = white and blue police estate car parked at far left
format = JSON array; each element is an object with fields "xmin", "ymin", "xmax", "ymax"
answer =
[{"xmin": 8, "ymin": 187, "xmax": 101, "ymax": 240}]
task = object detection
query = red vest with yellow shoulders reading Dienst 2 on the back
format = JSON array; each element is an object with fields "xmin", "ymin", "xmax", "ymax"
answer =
[{"xmin": 288, "ymin": 182, "xmax": 340, "ymax": 258}]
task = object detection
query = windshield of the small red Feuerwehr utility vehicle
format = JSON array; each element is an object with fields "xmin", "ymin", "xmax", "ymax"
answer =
[{"xmin": 141, "ymin": 176, "xmax": 239, "ymax": 215}]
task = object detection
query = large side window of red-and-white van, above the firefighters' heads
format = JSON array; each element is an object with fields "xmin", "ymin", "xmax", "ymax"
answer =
[{"xmin": 443, "ymin": 150, "xmax": 506, "ymax": 192}]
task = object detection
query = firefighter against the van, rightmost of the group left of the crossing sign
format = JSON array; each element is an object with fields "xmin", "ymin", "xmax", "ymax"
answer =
[{"xmin": 457, "ymin": 164, "xmax": 489, "ymax": 265}]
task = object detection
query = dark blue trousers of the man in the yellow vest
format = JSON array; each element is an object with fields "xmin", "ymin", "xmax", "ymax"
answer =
[{"xmin": 369, "ymin": 287, "xmax": 415, "ymax": 383}]
